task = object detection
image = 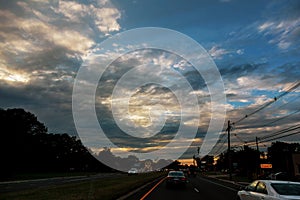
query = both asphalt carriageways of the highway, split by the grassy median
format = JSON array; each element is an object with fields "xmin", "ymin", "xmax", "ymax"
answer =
[{"xmin": 0, "ymin": 173, "xmax": 243, "ymax": 200}]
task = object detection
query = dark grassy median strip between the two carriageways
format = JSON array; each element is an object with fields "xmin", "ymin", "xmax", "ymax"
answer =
[{"xmin": 0, "ymin": 172, "xmax": 164, "ymax": 200}]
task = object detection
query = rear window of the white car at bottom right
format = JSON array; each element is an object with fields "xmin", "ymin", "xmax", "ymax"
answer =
[{"xmin": 271, "ymin": 183, "xmax": 300, "ymax": 195}]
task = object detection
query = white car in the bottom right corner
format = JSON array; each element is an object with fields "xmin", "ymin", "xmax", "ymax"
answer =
[{"xmin": 237, "ymin": 180, "xmax": 300, "ymax": 200}]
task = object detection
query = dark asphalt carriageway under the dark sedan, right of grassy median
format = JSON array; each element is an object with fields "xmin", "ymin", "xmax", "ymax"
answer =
[{"xmin": 141, "ymin": 177, "xmax": 237, "ymax": 200}]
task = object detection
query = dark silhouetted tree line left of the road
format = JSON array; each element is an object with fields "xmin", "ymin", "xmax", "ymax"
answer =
[{"xmin": 0, "ymin": 108, "xmax": 111, "ymax": 180}]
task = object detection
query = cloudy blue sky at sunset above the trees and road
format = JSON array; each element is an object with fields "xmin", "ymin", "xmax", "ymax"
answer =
[{"xmin": 0, "ymin": 0, "xmax": 300, "ymax": 164}]
